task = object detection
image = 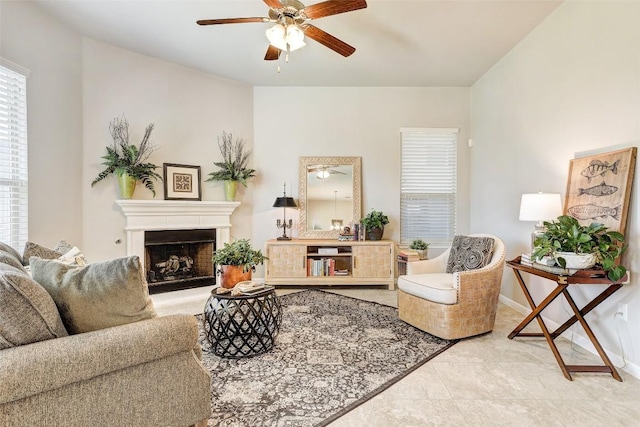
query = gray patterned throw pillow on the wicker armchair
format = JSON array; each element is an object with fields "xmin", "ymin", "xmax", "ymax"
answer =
[{"xmin": 446, "ymin": 236, "xmax": 494, "ymax": 273}]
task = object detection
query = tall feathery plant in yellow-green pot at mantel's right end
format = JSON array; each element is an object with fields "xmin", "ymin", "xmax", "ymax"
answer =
[{"xmin": 207, "ymin": 132, "xmax": 256, "ymax": 202}]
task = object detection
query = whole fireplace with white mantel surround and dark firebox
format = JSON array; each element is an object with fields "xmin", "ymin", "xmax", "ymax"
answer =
[{"xmin": 116, "ymin": 200, "xmax": 240, "ymax": 293}]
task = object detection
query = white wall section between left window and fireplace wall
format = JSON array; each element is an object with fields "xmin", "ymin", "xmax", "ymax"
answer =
[{"xmin": 0, "ymin": 1, "xmax": 83, "ymax": 252}]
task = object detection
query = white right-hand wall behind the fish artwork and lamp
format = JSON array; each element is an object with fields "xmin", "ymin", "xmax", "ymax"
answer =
[{"xmin": 471, "ymin": 2, "xmax": 640, "ymax": 376}]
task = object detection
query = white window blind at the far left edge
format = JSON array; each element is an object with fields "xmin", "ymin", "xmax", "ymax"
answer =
[{"xmin": 0, "ymin": 61, "xmax": 28, "ymax": 250}]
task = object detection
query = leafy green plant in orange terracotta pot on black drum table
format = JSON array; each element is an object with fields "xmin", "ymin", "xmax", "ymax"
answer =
[{"xmin": 213, "ymin": 239, "xmax": 267, "ymax": 288}]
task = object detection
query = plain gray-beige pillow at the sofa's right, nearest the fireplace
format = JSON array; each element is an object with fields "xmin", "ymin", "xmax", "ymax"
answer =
[{"xmin": 29, "ymin": 256, "xmax": 156, "ymax": 334}]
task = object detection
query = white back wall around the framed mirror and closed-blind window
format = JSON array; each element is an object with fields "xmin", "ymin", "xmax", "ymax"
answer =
[{"xmin": 253, "ymin": 87, "xmax": 470, "ymax": 276}]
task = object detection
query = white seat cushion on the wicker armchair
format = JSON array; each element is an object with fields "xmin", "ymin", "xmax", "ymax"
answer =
[{"xmin": 398, "ymin": 273, "xmax": 458, "ymax": 304}]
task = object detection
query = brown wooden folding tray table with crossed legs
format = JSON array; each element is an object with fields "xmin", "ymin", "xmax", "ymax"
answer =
[{"xmin": 507, "ymin": 257, "xmax": 627, "ymax": 381}]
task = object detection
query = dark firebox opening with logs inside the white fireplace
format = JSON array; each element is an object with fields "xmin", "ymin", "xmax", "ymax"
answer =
[{"xmin": 144, "ymin": 229, "xmax": 216, "ymax": 294}]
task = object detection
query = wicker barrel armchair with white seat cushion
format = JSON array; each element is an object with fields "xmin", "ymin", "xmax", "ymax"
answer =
[{"xmin": 398, "ymin": 234, "xmax": 506, "ymax": 339}]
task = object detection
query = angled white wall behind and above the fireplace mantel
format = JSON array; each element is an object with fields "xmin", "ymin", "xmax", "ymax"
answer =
[{"xmin": 82, "ymin": 39, "xmax": 258, "ymax": 261}]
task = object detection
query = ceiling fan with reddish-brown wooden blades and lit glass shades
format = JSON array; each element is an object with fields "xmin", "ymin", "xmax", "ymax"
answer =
[{"xmin": 197, "ymin": 0, "xmax": 367, "ymax": 61}]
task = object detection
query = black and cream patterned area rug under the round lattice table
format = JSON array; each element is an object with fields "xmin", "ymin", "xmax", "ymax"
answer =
[{"xmin": 199, "ymin": 290, "xmax": 455, "ymax": 427}]
